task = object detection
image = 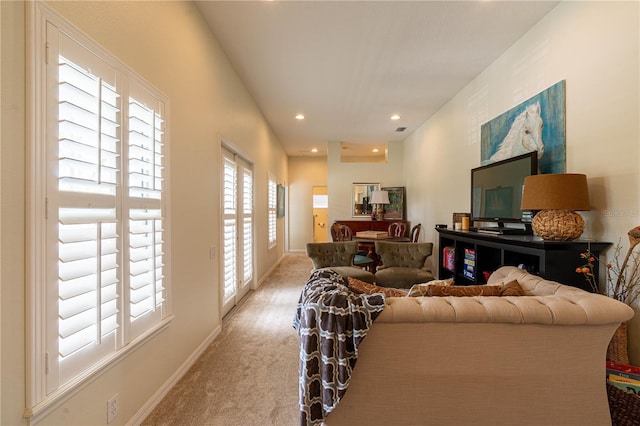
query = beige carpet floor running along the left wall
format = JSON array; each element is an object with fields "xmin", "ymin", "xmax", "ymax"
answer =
[{"xmin": 142, "ymin": 254, "xmax": 312, "ymax": 426}]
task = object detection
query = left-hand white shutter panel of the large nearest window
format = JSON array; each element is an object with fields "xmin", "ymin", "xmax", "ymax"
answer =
[{"xmin": 47, "ymin": 26, "xmax": 122, "ymax": 391}]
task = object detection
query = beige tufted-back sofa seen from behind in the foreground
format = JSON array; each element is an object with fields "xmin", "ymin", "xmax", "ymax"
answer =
[{"xmin": 325, "ymin": 267, "xmax": 633, "ymax": 426}]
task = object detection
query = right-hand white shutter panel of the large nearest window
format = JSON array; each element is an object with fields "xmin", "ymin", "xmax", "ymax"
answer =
[{"xmin": 126, "ymin": 80, "xmax": 165, "ymax": 339}]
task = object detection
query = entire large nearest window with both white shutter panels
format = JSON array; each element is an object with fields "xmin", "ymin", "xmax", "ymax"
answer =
[{"xmin": 29, "ymin": 3, "xmax": 169, "ymax": 411}]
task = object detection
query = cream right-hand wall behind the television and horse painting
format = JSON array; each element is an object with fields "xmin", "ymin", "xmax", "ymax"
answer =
[{"xmin": 404, "ymin": 2, "xmax": 640, "ymax": 365}]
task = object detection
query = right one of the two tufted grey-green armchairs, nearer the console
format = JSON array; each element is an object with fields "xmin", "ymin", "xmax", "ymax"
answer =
[{"xmin": 375, "ymin": 241, "xmax": 434, "ymax": 288}]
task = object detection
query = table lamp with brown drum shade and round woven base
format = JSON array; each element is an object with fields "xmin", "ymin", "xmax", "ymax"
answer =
[{"xmin": 520, "ymin": 173, "xmax": 590, "ymax": 241}]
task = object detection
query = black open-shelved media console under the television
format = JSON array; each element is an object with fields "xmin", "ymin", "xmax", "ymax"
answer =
[{"xmin": 436, "ymin": 228, "xmax": 611, "ymax": 291}]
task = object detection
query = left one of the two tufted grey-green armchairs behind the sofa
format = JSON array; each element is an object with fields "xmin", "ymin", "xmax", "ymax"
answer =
[{"xmin": 306, "ymin": 241, "xmax": 375, "ymax": 283}]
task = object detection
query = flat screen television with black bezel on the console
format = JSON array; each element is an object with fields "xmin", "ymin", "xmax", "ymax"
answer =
[{"xmin": 471, "ymin": 151, "xmax": 538, "ymax": 227}]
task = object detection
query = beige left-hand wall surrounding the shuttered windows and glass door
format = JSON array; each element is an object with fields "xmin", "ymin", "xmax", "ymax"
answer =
[{"xmin": 0, "ymin": 1, "xmax": 288, "ymax": 425}]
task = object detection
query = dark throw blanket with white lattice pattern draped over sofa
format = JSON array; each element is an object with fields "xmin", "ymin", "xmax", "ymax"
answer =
[{"xmin": 293, "ymin": 269, "xmax": 384, "ymax": 426}]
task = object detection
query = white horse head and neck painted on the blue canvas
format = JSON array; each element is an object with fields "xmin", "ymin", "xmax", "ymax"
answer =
[{"xmin": 490, "ymin": 102, "xmax": 544, "ymax": 162}]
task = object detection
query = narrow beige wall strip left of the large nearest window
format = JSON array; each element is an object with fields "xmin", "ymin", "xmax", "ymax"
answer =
[{"xmin": 0, "ymin": 2, "xmax": 25, "ymax": 424}]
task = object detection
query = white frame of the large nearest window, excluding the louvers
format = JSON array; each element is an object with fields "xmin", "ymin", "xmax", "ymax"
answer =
[{"xmin": 25, "ymin": 1, "xmax": 173, "ymax": 422}]
